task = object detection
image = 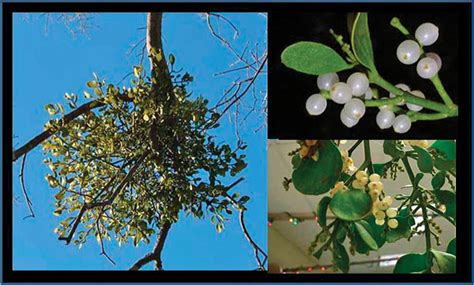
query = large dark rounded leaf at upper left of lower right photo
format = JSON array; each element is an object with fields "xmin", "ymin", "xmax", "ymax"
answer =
[{"xmin": 292, "ymin": 140, "xmax": 342, "ymax": 195}]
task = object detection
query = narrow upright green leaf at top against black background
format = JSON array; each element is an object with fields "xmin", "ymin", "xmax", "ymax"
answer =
[{"xmin": 351, "ymin": 13, "xmax": 376, "ymax": 71}]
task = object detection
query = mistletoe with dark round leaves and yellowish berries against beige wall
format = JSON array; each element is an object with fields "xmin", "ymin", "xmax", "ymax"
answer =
[{"xmin": 283, "ymin": 140, "xmax": 456, "ymax": 273}]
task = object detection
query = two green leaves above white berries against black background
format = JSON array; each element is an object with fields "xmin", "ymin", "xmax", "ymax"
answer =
[{"xmin": 281, "ymin": 13, "xmax": 375, "ymax": 75}]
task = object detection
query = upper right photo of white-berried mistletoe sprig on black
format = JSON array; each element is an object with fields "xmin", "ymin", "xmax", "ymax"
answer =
[{"xmin": 269, "ymin": 7, "xmax": 470, "ymax": 139}]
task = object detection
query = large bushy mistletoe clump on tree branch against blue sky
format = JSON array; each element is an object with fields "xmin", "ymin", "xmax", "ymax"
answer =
[{"xmin": 13, "ymin": 13, "xmax": 267, "ymax": 270}]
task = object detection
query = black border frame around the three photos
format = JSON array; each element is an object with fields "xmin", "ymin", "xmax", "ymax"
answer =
[{"xmin": 2, "ymin": 2, "xmax": 472, "ymax": 282}]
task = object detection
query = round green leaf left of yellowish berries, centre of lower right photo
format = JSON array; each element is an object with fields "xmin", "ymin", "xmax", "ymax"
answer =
[{"xmin": 329, "ymin": 190, "xmax": 372, "ymax": 221}]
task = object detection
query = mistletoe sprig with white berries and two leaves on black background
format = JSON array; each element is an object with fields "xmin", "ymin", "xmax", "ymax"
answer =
[{"xmin": 281, "ymin": 13, "xmax": 458, "ymax": 133}]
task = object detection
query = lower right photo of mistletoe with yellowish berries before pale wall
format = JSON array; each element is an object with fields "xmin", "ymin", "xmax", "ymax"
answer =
[{"xmin": 268, "ymin": 140, "xmax": 457, "ymax": 274}]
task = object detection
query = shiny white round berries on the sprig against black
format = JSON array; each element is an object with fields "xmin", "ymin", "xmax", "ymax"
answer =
[{"xmin": 306, "ymin": 23, "xmax": 442, "ymax": 134}]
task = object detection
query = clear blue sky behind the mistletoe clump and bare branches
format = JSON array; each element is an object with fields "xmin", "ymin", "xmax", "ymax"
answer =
[{"xmin": 13, "ymin": 13, "xmax": 267, "ymax": 270}]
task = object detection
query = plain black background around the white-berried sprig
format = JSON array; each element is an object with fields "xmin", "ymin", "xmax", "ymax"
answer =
[{"xmin": 268, "ymin": 6, "xmax": 471, "ymax": 139}]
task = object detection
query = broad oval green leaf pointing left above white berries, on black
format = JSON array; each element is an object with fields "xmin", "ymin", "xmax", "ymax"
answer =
[{"xmin": 281, "ymin": 42, "xmax": 352, "ymax": 75}]
